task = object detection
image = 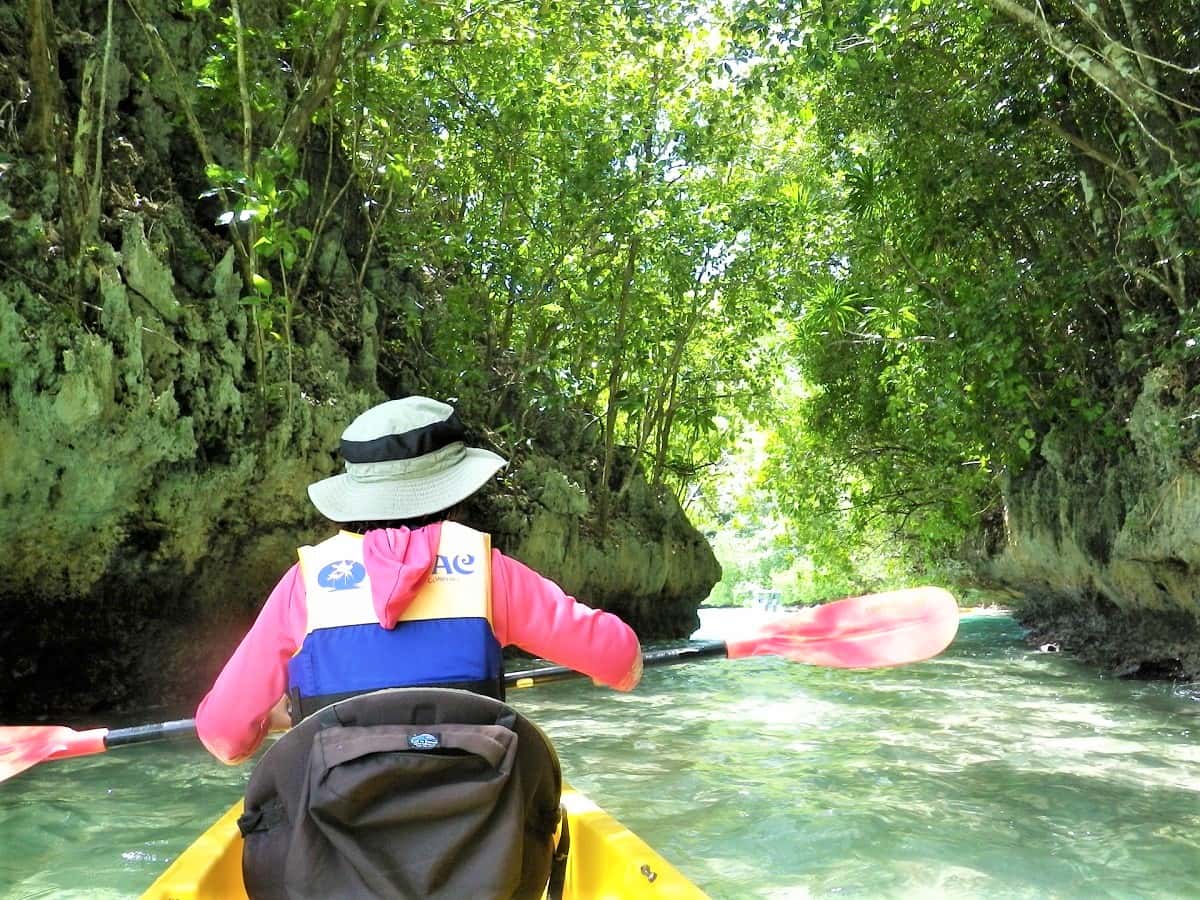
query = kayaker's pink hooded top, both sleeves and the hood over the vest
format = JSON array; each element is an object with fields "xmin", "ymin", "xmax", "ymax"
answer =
[{"xmin": 196, "ymin": 523, "xmax": 641, "ymax": 763}]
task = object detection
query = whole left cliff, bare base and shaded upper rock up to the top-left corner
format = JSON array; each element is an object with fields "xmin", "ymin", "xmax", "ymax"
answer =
[{"xmin": 0, "ymin": 0, "xmax": 720, "ymax": 721}]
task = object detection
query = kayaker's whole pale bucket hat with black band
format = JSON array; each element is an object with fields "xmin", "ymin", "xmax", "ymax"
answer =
[{"xmin": 308, "ymin": 397, "xmax": 505, "ymax": 522}]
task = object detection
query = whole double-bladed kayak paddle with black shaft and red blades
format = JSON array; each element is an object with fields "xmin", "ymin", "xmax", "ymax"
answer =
[{"xmin": 0, "ymin": 588, "xmax": 959, "ymax": 781}]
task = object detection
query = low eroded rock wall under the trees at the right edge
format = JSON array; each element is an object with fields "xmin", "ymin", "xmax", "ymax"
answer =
[{"xmin": 986, "ymin": 370, "xmax": 1200, "ymax": 678}]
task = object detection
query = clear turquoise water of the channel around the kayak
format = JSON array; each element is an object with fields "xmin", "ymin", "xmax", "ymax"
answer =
[{"xmin": 0, "ymin": 611, "xmax": 1200, "ymax": 899}]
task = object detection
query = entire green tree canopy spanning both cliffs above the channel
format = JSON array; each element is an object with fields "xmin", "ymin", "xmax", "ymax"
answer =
[{"xmin": 18, "ymin": 0, "xmax": 1200, "ymax": 592}]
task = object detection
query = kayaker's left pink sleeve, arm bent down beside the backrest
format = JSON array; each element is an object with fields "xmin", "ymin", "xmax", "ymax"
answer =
[{"xmin": 196, "ymin": 565, "xmax": 308, "ymax": 764}]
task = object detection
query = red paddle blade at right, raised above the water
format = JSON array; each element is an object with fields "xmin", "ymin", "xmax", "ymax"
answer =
[{"xmin": 726, "ymin": 588, "xmax": 959, "ymax": 668}]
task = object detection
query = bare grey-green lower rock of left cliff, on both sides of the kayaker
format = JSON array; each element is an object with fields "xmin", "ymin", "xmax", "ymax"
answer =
[{"xmin": 0, "ymin": 222, "xmax": 720, "ymax": 721}]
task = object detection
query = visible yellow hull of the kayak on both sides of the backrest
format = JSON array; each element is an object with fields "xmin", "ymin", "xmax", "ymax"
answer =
[{"xmin": 142, "ymin": 785, "xmax": 707, "ymax": 900}]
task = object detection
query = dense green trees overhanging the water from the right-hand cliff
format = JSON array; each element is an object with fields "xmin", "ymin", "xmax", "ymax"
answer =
[{"xmin": 715, "ymin": 0, "xmax": 1200, "ymax": 571}]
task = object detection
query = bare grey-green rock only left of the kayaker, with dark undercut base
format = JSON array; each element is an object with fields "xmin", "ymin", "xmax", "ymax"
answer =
[{"xmin": 0, "ymin": 216, "xmax": 355, "ymax": 714}]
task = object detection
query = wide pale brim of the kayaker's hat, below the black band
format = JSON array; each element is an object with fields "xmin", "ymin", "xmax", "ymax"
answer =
[{"xmin": 308, "ymin": 448, "xmax": 505, "ymax": 522}]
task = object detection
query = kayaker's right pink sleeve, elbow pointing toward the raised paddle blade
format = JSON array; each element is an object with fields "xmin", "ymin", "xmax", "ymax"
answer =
[{"xmin": 492, "ymin": 551, "xmax": 642, "ymax": 690}]
